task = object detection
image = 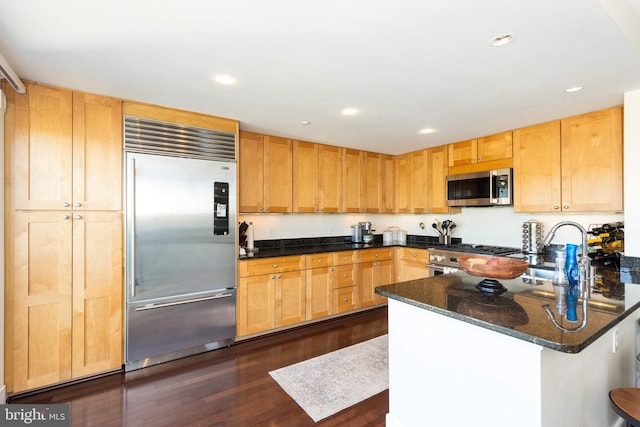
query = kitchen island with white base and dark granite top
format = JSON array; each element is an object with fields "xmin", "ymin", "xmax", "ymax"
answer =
[{"xmin": 376, "ymin": 272, "xmax": 640, "ymax": 427}]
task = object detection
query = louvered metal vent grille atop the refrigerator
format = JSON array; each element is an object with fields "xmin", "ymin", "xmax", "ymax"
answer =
[{"xmin": 124, "ymin": 116, "xmax": 236, "ymax": 161}]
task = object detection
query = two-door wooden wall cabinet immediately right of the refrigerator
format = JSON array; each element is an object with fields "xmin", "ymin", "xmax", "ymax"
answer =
[{"xmin": 238, "ymin": 132, "xmax": 293, "ymax": 213}]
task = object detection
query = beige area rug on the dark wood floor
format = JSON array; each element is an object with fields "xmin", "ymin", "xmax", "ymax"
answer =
[{"xmin": 269, "ymin": 335, "xmax": 389, "ymax": 422}]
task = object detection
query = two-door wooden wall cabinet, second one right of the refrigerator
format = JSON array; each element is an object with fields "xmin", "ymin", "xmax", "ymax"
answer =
[{"xmin": 293, "ymin": 141, "xmax": 342, "ymax": 213}]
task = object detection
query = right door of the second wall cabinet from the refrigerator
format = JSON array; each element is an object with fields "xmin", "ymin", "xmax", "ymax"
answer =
[{"xmin": 318, "ymin": 145, "xmax": 342, "ymax": 213}]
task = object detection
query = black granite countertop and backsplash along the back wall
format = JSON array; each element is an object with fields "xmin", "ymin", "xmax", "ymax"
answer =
[{"xmin": 239, "ymin": 235, "xmax": 462, "ymax": 260}]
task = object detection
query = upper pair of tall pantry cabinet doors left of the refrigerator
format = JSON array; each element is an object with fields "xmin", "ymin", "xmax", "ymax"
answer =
[{"xmin": 12, "ymin": 83, "xmax": 122, "ymax": 210}]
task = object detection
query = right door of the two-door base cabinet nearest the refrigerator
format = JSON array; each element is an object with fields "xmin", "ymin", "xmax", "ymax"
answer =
[{"xmin": 275, "ymin": 271, "xmax": 306, "ymax": 326}]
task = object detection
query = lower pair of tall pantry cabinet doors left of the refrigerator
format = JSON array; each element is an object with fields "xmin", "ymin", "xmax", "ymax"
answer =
[{"xmin": 7, "ymin": 211, "xmax": 123, "ymax": 392}]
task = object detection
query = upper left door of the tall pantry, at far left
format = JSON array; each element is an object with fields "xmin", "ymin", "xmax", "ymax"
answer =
[{"xmin": 13, "ymin": 83, "xmax": 73, "ymax": 210}]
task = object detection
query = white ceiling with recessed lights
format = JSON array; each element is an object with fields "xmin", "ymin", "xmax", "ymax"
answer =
[{"xmin": 0, "ymin": 0, "xmax": 640, "ymax": 154}]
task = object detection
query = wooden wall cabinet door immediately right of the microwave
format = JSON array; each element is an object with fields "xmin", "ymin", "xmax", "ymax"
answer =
[{"xmin": 513, "ymin": 120, "xmax": 561, "ymax": 212}]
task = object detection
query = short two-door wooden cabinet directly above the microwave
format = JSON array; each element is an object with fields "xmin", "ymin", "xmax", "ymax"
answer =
[{"xmin": 448, "ymin": 131, "xmax": 513, "ymax": 167}]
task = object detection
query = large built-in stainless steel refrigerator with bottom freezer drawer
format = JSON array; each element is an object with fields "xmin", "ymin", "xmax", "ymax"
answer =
[{"xmin": 125, "ymin": 117, "xmax": 237, "ymax": 370}]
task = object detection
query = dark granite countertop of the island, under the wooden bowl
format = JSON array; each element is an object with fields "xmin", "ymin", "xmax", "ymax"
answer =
[{"xmin": 376, "ymin": 271, "xmax": 640, "ymax": 353}]
